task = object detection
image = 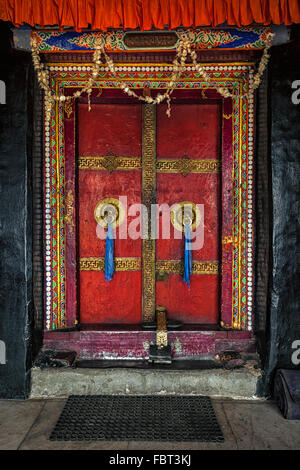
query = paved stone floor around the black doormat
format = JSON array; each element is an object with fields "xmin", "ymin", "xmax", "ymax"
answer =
[{"xmin": 0, "ymin": 398, "xmax": 300, "ymax": 450}]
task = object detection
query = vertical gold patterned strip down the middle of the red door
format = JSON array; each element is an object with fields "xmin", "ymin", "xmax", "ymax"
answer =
[{"xmin": 142, "ymin": 104, "xmax": 156, "ymax": 322}]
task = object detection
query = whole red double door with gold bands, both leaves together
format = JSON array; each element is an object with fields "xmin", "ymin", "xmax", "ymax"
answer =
[{"xmin": 77, "ymin": 93, "xmax": 222, "ymax": 325}]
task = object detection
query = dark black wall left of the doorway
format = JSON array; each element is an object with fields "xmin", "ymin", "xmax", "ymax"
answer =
[{"xmin": 0, "ymin": 23, "xmax": 33, "ymax": 398}]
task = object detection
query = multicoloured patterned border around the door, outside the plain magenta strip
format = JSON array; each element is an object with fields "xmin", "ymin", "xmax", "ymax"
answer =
[{"xmin": 45, "ymin": 63, "xmax": 254, "ymax": 330}]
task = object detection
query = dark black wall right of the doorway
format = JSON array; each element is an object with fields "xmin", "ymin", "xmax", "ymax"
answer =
[{"xmin": 257, "ymin": 26, "xmax": 300, "ymax": 396}]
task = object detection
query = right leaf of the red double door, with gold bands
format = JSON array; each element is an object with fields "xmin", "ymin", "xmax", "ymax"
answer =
[{"xmin": 156, "ymin": 100, "xmax": 221, "ymax": 324}]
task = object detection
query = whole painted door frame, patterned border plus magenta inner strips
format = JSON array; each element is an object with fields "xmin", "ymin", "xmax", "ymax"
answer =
[{"xmin": 44, "ymin": 62, "xmax": 254, "ymax": 330}]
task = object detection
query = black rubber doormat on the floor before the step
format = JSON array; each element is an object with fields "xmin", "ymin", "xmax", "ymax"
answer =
[{"xmin": 50, "ymin": 395, "xmax": 224, "ymax": 442}]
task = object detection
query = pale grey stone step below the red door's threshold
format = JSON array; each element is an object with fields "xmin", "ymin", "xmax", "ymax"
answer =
[{"xmin": 31, "ymin": 367, "xmax": 259, "ymax": 399}]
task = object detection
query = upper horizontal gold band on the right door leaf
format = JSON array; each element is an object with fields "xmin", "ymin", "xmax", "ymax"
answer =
[{"xmin": 156, "ymin": 155, "xmax": 221, "ymax": 176}]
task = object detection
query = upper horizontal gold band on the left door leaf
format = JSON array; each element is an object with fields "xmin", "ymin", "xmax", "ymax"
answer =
[{"xmin": 78, "ymin": 154, "xmax": 142, "ymax": 173}]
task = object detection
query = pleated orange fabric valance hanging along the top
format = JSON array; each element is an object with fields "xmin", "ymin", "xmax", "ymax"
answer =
[{"xmin": 0, "ymin": 0, "xmax": 300, "ymax": 31}]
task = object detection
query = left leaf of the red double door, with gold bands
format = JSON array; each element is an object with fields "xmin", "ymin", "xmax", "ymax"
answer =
[{"xmin": 78, "ymin": 103, "xmax": 142, "ymax": 324}]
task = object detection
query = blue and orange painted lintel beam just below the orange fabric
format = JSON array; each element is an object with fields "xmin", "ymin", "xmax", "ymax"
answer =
[{"xmin": 31, "ymin": 26, "xmax": 271, "ymax": 52}]
